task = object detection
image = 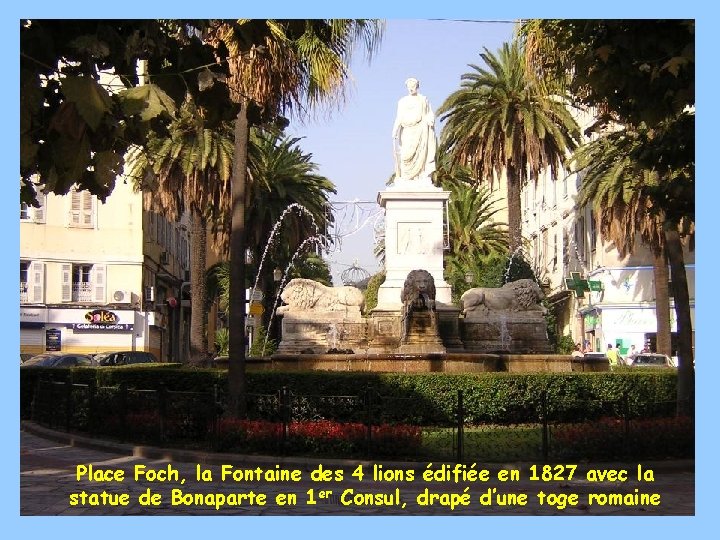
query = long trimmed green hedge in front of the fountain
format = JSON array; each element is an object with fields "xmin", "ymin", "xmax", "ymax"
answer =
[{"xmin": 21, "ymin": 364, "xmax": 677, "ymax": 425}]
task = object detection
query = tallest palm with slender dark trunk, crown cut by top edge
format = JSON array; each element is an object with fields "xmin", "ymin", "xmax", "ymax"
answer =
[{"xmin": 206, "ymin": 19, "xmax": 382, "ymax": 415}]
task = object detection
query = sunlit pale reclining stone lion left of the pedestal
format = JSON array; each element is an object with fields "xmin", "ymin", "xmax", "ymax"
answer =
[{"xmin": 277, "ymin": 278, "xmax": 364, "ymax": 313}]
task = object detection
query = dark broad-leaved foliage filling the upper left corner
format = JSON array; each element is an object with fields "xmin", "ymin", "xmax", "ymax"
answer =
[{"xmin": 20, "ymin": 19, "xmax": 224, "ymax": 204}]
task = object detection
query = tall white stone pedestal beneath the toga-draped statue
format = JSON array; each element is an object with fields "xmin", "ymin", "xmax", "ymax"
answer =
[{"xmin": 377, "ymin": 186, "xmax": 451, "ymax": 311}]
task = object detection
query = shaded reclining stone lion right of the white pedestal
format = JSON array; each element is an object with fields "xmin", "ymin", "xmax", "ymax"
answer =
[{"xmin": 460, "ymin": 279, "xmax": 547, "ymax": 314}]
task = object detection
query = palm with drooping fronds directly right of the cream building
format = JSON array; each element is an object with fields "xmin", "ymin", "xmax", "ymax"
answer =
[{"xmin": 128, "ymin": 96, "xmax": 233, "ymax": 364}]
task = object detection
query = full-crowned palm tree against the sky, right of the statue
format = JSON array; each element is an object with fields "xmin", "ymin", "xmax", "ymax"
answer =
[{"xmin": 438, "ymin": 41, "xmax": 580, "ymax": 251}]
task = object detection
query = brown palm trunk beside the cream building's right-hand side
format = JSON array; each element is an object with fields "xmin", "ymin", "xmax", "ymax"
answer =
[{"xmin": 188, "ymin": 211, "xmax": 208, "ymax": 365}]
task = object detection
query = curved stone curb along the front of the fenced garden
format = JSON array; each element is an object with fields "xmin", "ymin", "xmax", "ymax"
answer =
[{"xmin": 20, "ymin": 420, "xmax": 695, "ymax": 474}]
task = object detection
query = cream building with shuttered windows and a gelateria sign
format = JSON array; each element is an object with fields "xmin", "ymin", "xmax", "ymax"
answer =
[{"xmin": 20, "ymin": 182, "xmax": 189, "ymax": 361}]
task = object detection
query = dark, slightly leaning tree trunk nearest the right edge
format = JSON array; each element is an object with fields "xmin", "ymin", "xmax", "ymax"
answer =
[{"xmin": 665, "ymin": 228, "xmax": 695, "ymax": 415}]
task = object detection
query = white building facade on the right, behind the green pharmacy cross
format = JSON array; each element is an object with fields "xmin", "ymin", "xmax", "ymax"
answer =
[{"xmin": 522, "ymin": 110, "xmax": 695, "ymax": 354}]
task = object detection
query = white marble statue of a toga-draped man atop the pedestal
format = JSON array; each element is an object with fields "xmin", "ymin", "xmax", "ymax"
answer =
[{"xmin": 393, "ymin": 78, "xmax": 437, "ymax": 180}]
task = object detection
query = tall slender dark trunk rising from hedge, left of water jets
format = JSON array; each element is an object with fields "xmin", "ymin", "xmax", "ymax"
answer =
[{"xmin": 227, "ymin": 102, "xmax": 249, "ymax": 417}]
